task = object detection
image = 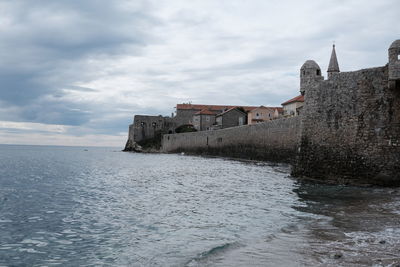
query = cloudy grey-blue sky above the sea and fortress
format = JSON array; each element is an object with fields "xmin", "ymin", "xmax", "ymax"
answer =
[{"xmin": 0, "ymin": 0, "xmax": 400, "ymax": 148}]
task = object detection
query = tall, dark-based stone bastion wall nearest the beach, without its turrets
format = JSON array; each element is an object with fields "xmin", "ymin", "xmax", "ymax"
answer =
[{"xmin": 293, "ymin": 66, "xmax": 400, "ymax": 185}]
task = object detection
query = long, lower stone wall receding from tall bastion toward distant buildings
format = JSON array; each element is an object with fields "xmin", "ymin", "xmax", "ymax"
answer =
[{"xmin": 162, "ymin": 116, "xmax": 301, "ymax": 162}]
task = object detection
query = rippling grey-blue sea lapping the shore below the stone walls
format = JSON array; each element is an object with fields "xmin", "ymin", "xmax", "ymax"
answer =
[{"xmin": 0, "ymin": 145, "xmax": 400, "ymax": 266}]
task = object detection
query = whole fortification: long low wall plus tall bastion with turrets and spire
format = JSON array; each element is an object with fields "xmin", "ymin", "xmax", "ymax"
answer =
[{"xmin": 162, "ymin": 40, "xmax": 400, "ymax": 185}]
